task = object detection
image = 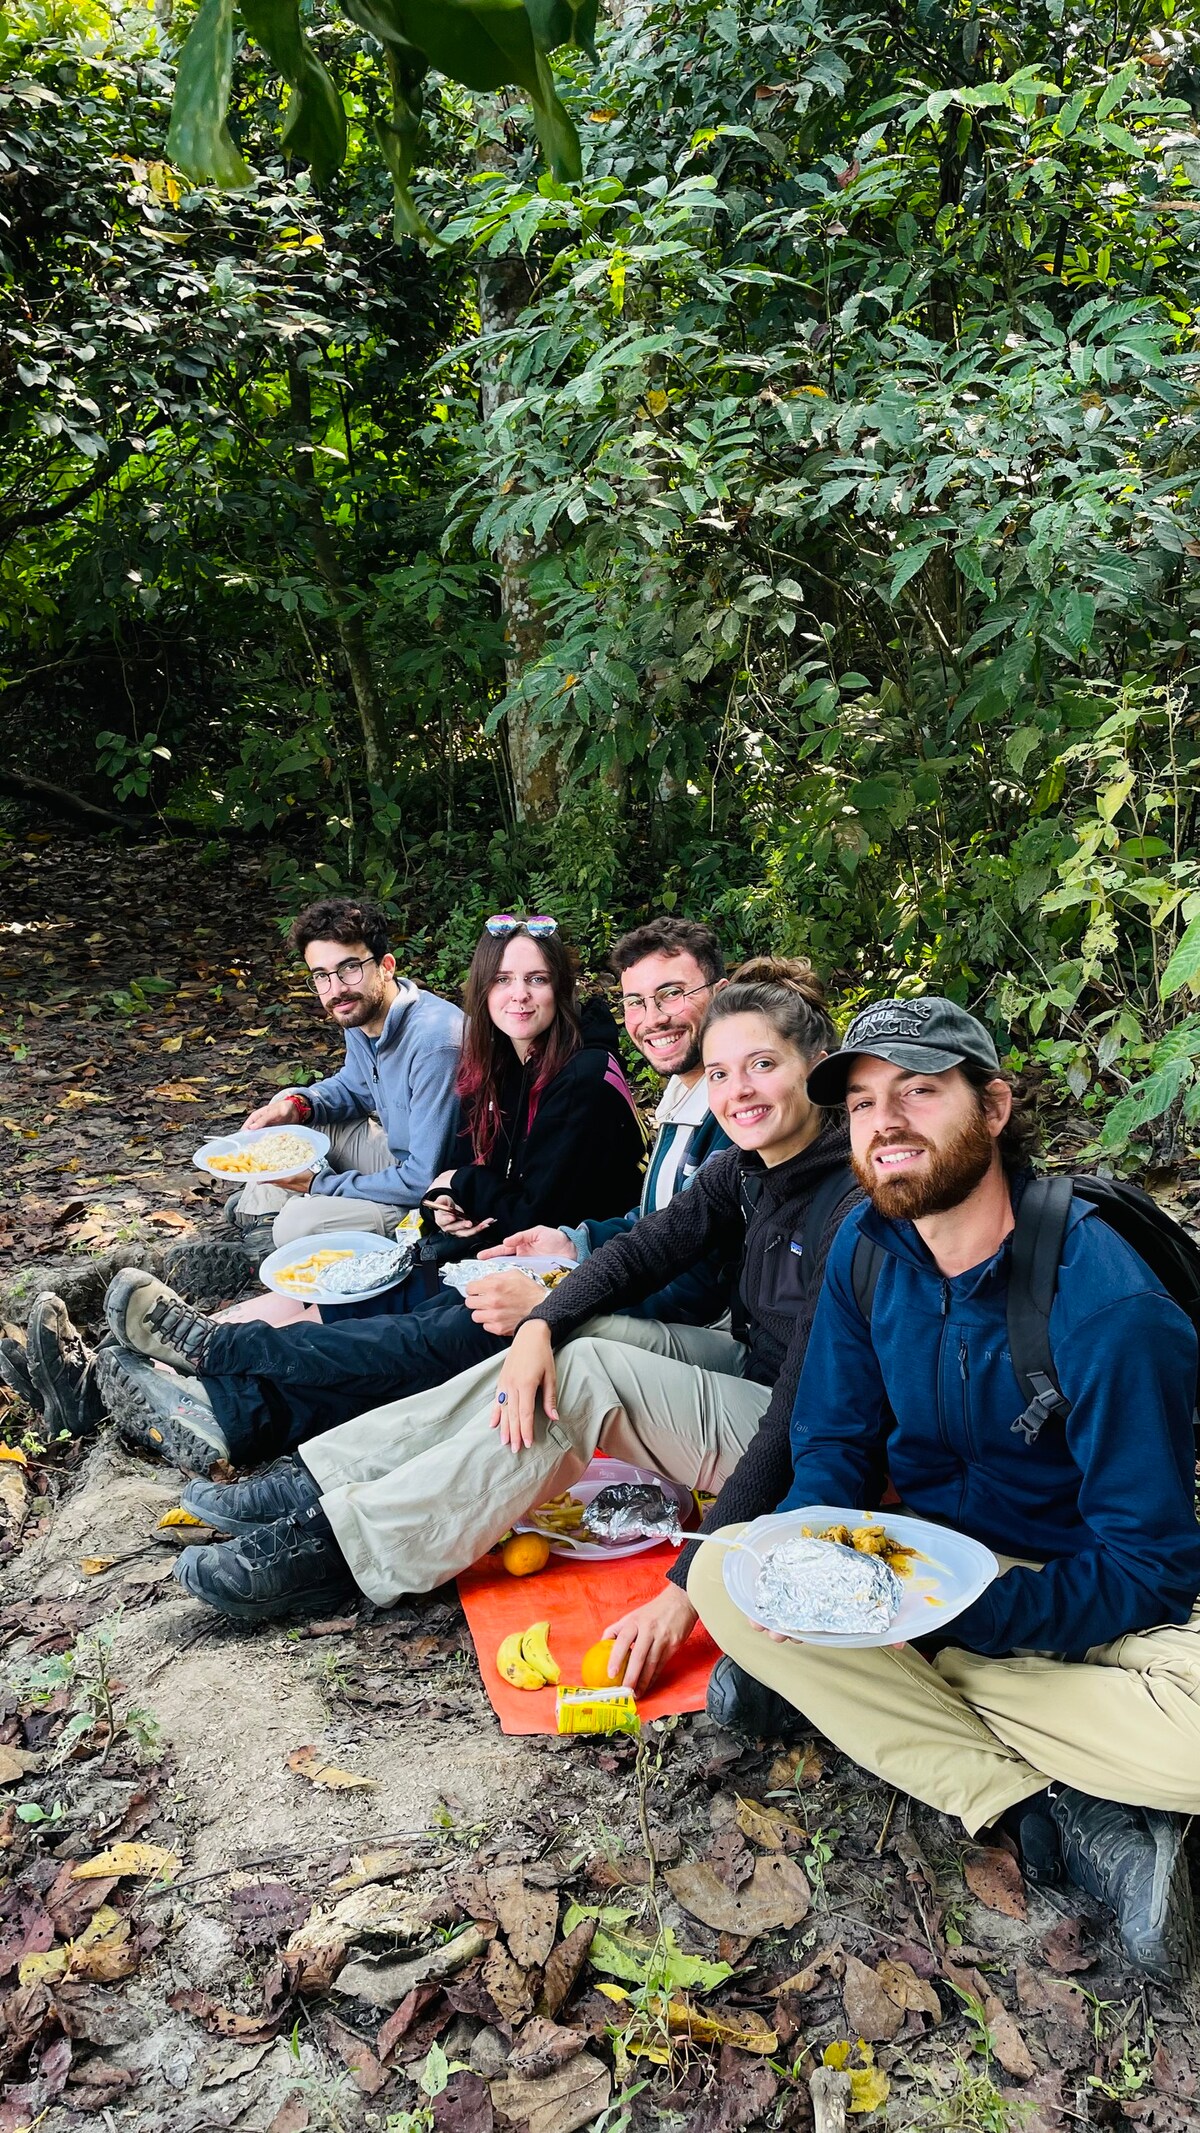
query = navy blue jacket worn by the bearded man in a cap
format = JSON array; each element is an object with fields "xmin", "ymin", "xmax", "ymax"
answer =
[{"xmin": 782, "ymin": 1199, "xmax": 1200, "ymax": 1657}]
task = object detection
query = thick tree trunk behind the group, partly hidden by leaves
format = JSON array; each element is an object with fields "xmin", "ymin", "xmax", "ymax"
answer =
[{"xmin": 477, "ymin": 141, "xmax": 561, "ymax": 821}]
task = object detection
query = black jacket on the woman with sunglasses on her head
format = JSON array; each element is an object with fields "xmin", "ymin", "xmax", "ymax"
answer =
[{"xmin": 441, "ymin": 1000, "xmax": 646, "ymax": 1258}]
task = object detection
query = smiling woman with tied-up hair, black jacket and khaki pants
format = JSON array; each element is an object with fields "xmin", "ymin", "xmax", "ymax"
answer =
[{"xmin": 179, "ymin": 958, "xmax": 859, "ymax": 1629}]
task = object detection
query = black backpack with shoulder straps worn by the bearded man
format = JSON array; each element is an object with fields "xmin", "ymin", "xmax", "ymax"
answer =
[{"xmin": 850, "ymin": 1177, "xmax": 1200, "ymax": 1448}]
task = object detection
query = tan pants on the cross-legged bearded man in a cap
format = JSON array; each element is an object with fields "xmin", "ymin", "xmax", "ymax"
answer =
[{"xmin": 688, "ymin": 1525, "xmax": 1200, "ymax": 1837}]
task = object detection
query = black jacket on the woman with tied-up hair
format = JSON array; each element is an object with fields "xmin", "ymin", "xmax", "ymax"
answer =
[{"xmin": 531, "ymin": 1120, "xmax": 863, "ymax": 1585}]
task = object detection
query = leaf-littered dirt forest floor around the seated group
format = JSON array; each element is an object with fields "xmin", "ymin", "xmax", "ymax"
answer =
[{"xmin": 0, "ymin": 834, "xmax": 1200, "ymax": 2133}]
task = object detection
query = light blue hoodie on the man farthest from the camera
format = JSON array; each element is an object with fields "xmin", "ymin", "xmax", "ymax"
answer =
[{"xmin": 296, "ymin": 977, "xmax": 465, "ymax": 1207}]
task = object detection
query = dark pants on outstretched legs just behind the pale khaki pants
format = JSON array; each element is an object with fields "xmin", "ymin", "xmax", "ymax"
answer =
[{"xmin": 200, "ymin": 1288, "xmax": 507, "ymax": 1465}]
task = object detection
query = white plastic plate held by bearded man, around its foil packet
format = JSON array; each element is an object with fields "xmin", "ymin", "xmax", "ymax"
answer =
[{"xmin": 723, "ymin": 1504, "xmax": 1000, "ymax": 1651}]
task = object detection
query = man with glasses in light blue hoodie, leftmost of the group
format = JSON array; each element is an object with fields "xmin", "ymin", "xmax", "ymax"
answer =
[{"xmin": 213, "ymin": 896, "xmax": 463, "ymax": 1286}]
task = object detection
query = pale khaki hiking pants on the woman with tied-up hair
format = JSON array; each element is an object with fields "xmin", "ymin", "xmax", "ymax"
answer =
[{"xmin": 301, "ymin": 1318, "xmax": 769, "ymax": 1606}]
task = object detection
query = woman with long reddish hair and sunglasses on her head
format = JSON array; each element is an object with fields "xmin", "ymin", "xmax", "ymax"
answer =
[{"xmin": 426, "ymin": 913, "xmax": 646, "ymax": 1258}]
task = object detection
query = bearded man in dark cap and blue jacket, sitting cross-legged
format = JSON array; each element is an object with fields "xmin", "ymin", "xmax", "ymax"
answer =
[{"xmin": 688, "ymin": 996, "xmax": 1200, "ymax": 1984}]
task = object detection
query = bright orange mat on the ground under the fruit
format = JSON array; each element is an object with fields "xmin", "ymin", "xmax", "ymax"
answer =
[{"xmin": 458, "ymin": 1546, "xmax": 720, "ymax": 1734}]
